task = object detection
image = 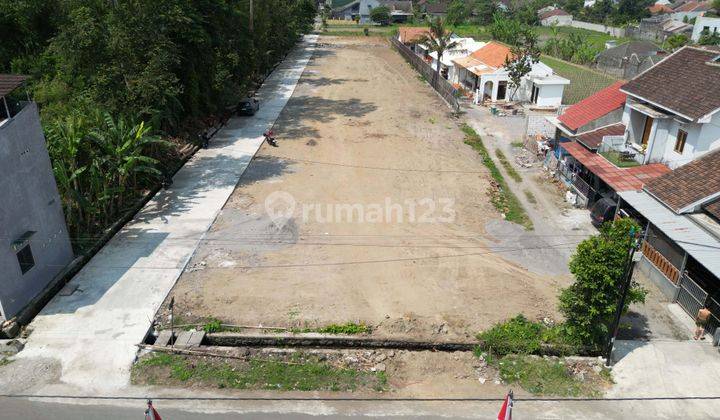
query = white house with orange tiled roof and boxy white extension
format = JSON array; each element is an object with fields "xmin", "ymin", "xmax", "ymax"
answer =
[{"xmin": 450, "ymin": 41, "xmax": 570, "ymax": 108}]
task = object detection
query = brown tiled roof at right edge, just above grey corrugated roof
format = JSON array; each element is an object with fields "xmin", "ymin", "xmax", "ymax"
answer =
[{"xmin": 645, "ymin": 150, "xmax": 720, "ymax": 213}]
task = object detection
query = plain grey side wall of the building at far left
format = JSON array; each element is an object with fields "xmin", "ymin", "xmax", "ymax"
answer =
[{"xmin": 0, "ymin": 103, "xmax": 73, "ymax": 319}]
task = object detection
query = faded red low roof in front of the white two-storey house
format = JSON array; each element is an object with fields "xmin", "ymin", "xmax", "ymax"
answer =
[{"xmin": 560, "ymin": 142, "xmax": 670, "ymax": 192}]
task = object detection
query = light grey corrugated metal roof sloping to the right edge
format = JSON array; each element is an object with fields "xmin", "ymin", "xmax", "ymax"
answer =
[{"xmin": 619, "ymin": 191, "xmax": 720, "ymax": 276}]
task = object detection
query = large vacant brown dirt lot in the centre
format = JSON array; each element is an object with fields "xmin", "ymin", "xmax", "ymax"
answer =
[{"xmin": 162, "ymin": 37, "xmax": 565, "ymax": 339}]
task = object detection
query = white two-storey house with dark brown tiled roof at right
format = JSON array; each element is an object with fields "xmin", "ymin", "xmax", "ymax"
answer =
[{"xmin": 619, "ymin": 47, "xmax": 720, "ymax": 169}]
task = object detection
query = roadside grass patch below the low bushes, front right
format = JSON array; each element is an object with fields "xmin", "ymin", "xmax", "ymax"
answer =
[{"xmin": 496, "ymin": 355, "xmax": 601, "ymax": 397}]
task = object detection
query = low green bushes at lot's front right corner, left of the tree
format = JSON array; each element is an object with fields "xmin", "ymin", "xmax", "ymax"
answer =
[{"xmin": 476, "ymin": 315, "xmax": 580, "ymax": 356}]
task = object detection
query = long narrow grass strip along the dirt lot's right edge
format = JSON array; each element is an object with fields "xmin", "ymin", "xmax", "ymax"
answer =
[{"xmin": 462, "ymin": 124, "xmax": 533, "ymax": 230}]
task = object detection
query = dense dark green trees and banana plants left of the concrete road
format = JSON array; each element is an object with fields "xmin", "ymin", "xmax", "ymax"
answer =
[{"xmin": 0, "ymin": 0, "xmax": 317, "ymax": 250}]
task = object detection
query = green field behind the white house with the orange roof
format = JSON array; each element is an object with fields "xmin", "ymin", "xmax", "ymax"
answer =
[{"xmin": 540, "ymin": 55, "xmax": 617, "ymax": 104}]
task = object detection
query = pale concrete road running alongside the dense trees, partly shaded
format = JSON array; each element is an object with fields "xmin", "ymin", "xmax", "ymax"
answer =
[{"xmin": 18, "ymin": 35, "xmax": 317, "ymax": 392}]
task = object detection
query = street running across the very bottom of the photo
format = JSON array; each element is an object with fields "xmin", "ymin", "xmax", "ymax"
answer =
[{"xmin": 0, "ymin": 398, "xmax": 720, "ymax": 420}]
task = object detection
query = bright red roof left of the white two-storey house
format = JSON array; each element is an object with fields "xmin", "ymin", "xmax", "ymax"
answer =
[{"xmin": 558, "ymin": 81, "xmax": 626, "ymax": 130}]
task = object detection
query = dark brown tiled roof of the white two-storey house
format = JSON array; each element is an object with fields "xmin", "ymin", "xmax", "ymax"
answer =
[{"xmin": 622, "ymin": 47, "xmax": 720, "ymax": 120}]
